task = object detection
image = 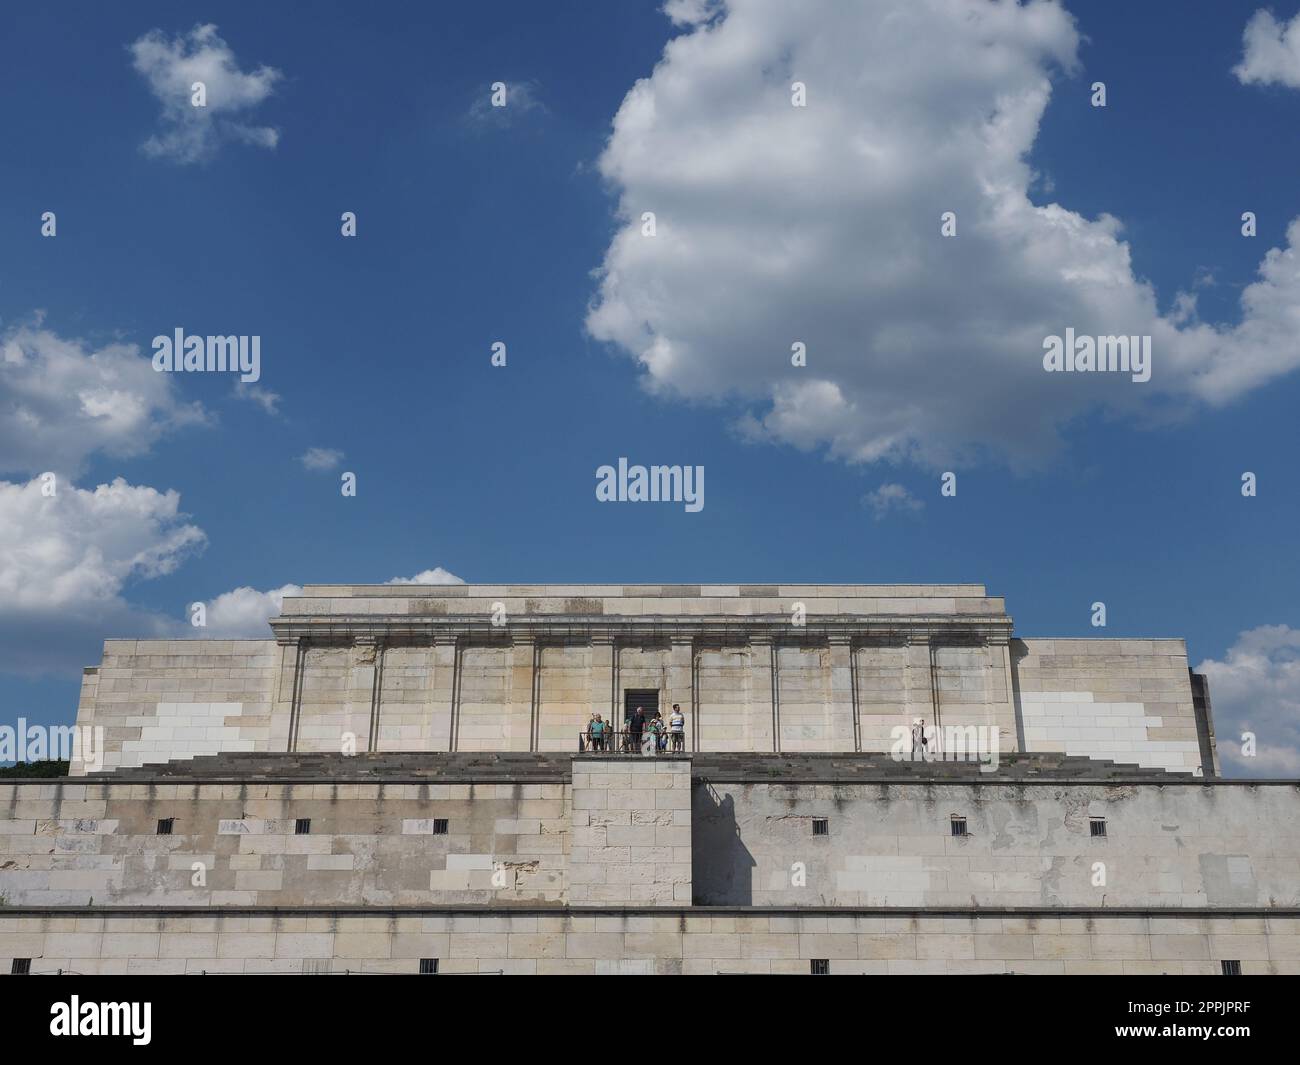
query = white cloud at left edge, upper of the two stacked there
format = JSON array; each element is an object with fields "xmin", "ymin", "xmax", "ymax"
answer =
[{"xmin": 0, "ymin": 326, "xmax": 208, "ymax": 476}]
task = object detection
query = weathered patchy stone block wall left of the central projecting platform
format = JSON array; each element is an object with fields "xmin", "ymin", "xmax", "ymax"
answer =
[{"xmin": 0, "ymin": 782, "xmax": 569, "ymax": 906}]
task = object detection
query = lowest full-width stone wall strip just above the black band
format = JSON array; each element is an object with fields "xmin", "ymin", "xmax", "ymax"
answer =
[{"xmin": 0, "ymin": 909, "xmax": 1300, "ymax": 975}]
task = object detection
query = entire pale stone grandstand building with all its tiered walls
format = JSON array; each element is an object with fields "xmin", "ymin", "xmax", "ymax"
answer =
[{"xmin": 0, "ymin": 585, "xmax": 1300, "ymax": 974}]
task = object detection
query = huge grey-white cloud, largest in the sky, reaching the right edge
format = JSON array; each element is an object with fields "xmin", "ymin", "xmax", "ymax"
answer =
[{"xmin": 588, "ymin": 0, "xmax": 1300, "ymax": 468}]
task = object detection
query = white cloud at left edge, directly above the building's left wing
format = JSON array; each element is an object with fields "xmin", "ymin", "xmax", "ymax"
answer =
[{"xmin": 0, "ymin": 477, "xmax": 207, "ymax": 674}]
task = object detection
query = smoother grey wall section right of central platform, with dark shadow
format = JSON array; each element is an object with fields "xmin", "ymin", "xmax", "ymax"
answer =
[{"xmin": 693, "ymin": 782, "xmax": 1300, "ymax": 908}]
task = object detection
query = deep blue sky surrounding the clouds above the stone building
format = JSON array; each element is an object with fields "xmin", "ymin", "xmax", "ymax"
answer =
[{"xmin": 0, "ymin": 0, "xmax": 1300, "ymax": 770}]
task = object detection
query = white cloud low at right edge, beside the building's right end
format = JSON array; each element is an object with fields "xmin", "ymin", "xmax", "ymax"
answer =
[{"xmin": 1196, "ymin": 625, "xmax": 1300, "ymax": 776}]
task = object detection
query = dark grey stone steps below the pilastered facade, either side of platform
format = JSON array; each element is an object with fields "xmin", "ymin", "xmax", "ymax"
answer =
[{"xmin": 85, "ymin": 752, "xmax": 1200, "ymax": 784}]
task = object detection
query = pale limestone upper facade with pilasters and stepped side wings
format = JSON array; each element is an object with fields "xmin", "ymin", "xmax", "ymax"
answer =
[{"xmin": 72, "ymin": 585, "xmax": 1217, "ymax": 775}]
